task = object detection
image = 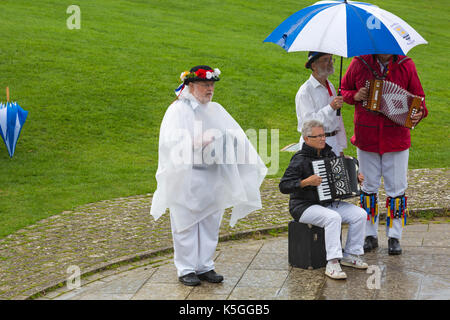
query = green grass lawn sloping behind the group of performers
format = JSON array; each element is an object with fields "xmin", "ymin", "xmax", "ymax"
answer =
[{"xmin": 0, "ymin": 0, "xmax": 450, "ymax": 237}]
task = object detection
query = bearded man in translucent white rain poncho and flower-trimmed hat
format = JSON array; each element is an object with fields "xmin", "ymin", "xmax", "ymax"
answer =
[{"xmin": 150, "ymin": 65, "xmax": 267, "ymax": 286}]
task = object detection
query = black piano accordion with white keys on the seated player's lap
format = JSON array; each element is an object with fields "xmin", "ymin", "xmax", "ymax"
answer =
[{"xmin": 311, "ymin": 156, "xmax": 361, "ymax": 202}]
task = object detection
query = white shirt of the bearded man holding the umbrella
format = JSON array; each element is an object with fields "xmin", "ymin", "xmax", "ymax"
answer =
[{"xmin": 295, "ymin": 74, "xmax": 347, "ymax": 155}]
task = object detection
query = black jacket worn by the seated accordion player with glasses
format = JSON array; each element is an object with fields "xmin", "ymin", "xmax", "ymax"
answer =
[{"xmin": 279, "ymin": 143, "xmax": 336, "ymax": 221}]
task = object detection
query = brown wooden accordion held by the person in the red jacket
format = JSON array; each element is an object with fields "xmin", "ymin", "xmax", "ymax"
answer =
[{"xmin": 363, "ymin": 79, "xmax": 423, "ymax": 128}]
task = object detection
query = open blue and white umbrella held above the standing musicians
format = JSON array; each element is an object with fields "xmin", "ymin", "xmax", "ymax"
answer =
[{"xmin": 264, "ymin": 0, "xmax": 427, "ymax": 57}]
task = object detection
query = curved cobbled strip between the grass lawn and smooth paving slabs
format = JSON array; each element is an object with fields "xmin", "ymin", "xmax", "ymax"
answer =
[{"xmin": 0, "ymin": 169, "xmax": 450, "ymax": 299}]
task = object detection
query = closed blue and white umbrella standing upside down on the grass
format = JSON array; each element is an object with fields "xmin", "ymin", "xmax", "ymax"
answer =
[{"xmin": 0, "ymin": 88, "xmax": 28, "ymax": 158}]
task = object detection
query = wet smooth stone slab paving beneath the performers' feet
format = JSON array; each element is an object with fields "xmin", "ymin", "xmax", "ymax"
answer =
[{"xmin": 39, "ymin": 221, "xmax": 450, "ymax": 300}]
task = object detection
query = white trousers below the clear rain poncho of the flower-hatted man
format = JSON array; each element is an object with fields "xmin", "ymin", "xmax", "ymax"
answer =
[{"xmin": 171, "ymin": 209, "xmax": 224, "ymax": 277}]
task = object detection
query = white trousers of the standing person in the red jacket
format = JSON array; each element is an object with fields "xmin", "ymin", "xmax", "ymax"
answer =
[{"xmin": 357, "ymin": 149, "xmax": 409, "ymax": 239}]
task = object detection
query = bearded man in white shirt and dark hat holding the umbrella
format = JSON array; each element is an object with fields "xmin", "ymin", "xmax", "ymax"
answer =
[{"xmin": 295, "ymin": 51, "xmax": 347, "ymax": 155}]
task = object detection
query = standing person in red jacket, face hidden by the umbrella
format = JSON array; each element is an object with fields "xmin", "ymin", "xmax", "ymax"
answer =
[{"xmin": 341, "ymin": 54, "xmax": 428, "ymax": 255}]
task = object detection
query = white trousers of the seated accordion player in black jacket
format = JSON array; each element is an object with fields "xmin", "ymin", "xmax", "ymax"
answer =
[{"xmin": 299, "ymin": 201, "xmax": 367, "ymax": 261}]
